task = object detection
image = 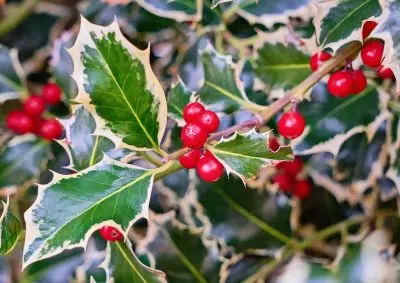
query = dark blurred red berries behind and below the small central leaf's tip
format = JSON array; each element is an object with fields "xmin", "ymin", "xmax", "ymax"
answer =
[{"xmin": 269, "ymin": 138, "xmax": 311, "ymax": 199}]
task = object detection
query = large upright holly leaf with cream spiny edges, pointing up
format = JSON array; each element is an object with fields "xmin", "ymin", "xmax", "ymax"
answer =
[{"xmin": 69, "ymin": 17, "xmax": 167, "ymax": 153}]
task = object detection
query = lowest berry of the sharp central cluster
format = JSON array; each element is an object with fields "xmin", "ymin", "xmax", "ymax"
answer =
[{"xmin": 197, "ymin": 152, "xmax": 224, "ymax": 183}]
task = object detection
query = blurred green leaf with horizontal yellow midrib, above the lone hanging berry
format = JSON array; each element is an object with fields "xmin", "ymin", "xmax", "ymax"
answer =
[{"xmin": 255, "ymin": 42, "xmax": 311, "ymax": 89}]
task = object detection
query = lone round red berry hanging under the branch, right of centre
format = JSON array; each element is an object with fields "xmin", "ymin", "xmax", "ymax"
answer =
[{"xmin": 278, "ymin": 111, "xmax": 306, "ymax": 139}]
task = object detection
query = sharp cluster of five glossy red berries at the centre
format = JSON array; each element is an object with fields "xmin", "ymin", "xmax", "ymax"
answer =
[{"xmin": 179, "ymin": 102, "xmax": 224, "ymax": 182}]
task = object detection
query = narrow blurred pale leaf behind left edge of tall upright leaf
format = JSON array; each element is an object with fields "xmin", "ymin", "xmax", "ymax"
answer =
[{"xmin": 50, "ymin": 31, "xmax": 78, "ymax": 103}]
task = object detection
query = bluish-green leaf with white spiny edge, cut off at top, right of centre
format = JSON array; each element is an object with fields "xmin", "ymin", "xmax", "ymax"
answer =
[{"xmin": 235, "ymin": 0, "xmax": 316, "ymax": 28}]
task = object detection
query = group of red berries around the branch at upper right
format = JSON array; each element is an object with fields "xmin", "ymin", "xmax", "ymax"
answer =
[{"xmin": 310, "ymin": 21, "xmax": 393, "ymax": 98}]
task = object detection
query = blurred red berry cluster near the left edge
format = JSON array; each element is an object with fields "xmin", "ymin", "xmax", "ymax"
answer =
[{"xmin": 6, "ymin": 83, "xmax": 63, "ymax": 140}]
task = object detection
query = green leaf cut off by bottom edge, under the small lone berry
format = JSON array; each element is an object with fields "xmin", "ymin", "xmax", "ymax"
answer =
[{"xmin": 106, "ymin": 242, "xmax": 167, "ymax": 283}]
